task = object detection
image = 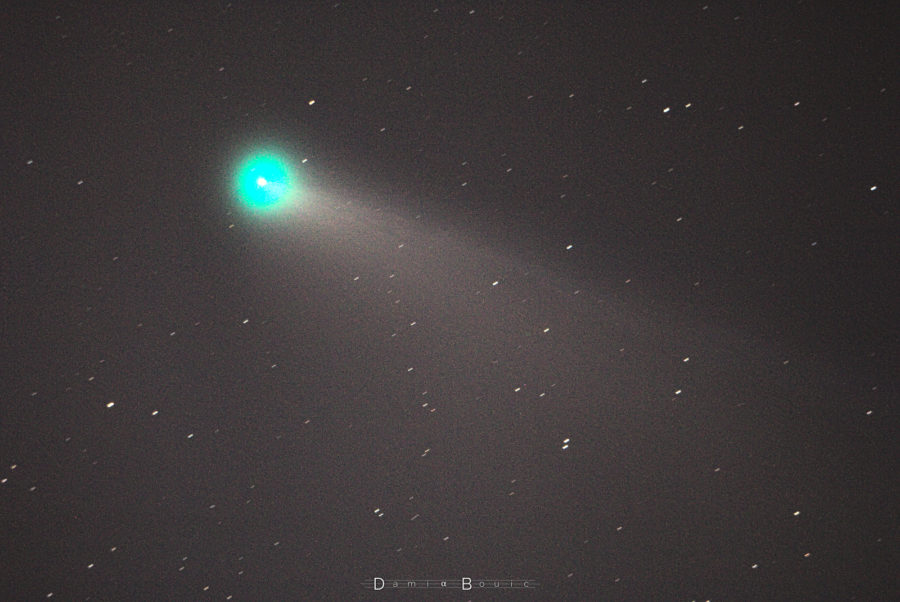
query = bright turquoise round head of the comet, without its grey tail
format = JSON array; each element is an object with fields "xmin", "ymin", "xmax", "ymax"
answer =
[{"xmin": 237, "ymin": 153, "xmax": 296, "ymax": 212}]
